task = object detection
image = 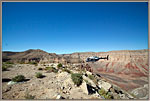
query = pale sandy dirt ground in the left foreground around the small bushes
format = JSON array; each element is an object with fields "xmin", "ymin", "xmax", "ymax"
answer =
[{"xmin": 2, "ymin": 64, "xmax": 102, "ymax": 99}]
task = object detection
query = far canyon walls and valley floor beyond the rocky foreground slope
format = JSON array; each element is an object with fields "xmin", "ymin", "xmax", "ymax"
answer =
[{"xmin": 2, "ymin": 49, "xmax": 149, "ymax": 99}]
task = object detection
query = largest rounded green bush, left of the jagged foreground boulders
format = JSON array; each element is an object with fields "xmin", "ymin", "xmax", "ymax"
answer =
[{"xmin": 71, "ymin": 73, "xmax": 83, "ymax": 86}]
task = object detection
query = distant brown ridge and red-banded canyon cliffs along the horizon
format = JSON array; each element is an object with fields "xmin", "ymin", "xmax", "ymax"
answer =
[{"xmin": 2, "ymin": 49, "xmax": 148, "ymax": 76}]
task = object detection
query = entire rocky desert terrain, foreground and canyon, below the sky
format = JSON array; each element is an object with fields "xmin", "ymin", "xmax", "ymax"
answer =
[{"xmin": 2, "ymin": 49, "xmax": 149, "ymax": 99}]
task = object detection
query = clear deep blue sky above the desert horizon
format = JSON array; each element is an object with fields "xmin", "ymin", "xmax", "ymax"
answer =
[{"xmin": 2, "ymin": 2, "xmax": 148, "ymax": 54}]
